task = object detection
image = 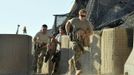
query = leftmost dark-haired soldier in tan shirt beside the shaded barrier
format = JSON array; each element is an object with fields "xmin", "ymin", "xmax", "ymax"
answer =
[{"xmin": 33, "ymin": 24, "xmax": 49, "ymax": 73}]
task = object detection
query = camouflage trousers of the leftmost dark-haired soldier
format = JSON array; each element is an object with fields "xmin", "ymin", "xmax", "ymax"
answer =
[{"xmin": 33, "ymin": 48, "xmax": 47, "ymax": 73}]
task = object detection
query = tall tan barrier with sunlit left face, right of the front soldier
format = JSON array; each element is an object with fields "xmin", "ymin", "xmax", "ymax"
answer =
[{"xmin": 101, "ymin": 28, "xmax": 131, "ymax": 75}]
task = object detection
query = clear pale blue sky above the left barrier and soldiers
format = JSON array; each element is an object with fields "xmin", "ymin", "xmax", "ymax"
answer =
[{"xmin": 0, "ymin": 0, "xmax": 74, "ymax": 37}]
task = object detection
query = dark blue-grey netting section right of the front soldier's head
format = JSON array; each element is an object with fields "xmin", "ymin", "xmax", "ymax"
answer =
[{"xmin": 90, "ymin": 0, "xmax": 134, "ymax": 27}]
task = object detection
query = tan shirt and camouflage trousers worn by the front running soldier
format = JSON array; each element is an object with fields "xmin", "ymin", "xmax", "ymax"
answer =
[{"xmin": 66, "ymin": 18, "xmax": 92, "ymax": 70}]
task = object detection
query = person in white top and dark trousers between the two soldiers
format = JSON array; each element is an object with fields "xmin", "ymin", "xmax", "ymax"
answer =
[{"xmin": 45, "ymin": 26, "xmax": 65, "ymax": 74}]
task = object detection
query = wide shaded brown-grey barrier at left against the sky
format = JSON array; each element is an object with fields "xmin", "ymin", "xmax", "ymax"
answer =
[{"xmin": 0, "ymin": 34, "xmax": 32, "ymax": 75}]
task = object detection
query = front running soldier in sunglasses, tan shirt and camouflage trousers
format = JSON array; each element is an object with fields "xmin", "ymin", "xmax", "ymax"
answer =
[{"xmin": 65, "ymin": 9, "xmax": 93, "ymax": 75}]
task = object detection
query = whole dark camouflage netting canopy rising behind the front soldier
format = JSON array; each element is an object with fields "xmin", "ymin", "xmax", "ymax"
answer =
[{"xmin": 53, "ymin": 0, "xmax": 134, "ymax": 32}]
